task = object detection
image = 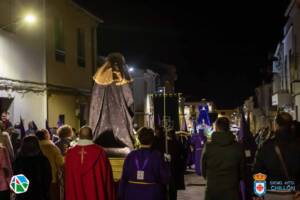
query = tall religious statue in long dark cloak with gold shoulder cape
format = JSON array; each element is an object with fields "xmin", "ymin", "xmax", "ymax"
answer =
[{"xmin": 89, "ymin": 53, "xmax": 133, "ymax": 154}]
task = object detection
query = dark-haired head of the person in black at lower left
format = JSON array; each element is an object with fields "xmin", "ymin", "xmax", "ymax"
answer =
[{"xmin": 20, "ymin": 135, "xmax": 41, "ymax": 156}]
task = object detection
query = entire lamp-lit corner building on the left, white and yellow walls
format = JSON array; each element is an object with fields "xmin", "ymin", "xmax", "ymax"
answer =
[{"xmin": 0, "ymin": 0, "xmax": 101, "ymax": 128}]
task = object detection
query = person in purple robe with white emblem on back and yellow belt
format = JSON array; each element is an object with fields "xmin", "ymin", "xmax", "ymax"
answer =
[{"xmin": 118, "ymin": 127, "xmax": 171, "ymax": 200}]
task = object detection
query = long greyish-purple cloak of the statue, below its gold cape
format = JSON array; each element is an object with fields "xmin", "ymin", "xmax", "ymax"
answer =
[{"xmin": 90, "ymin": 83, "xmax": 133, "ymax": 149}]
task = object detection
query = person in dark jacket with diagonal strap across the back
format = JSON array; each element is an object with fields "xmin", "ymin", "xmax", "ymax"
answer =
[{"xmin": 254, "ymin": 112, "xmax": 300, "ymax": 200}]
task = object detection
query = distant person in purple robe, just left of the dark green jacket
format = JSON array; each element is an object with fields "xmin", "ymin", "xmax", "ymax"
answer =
[{"xmin": 191, "ymin": 129, "xmax": 206, "ymax": 176}]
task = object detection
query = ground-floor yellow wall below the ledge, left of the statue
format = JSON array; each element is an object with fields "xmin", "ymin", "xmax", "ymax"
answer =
[{"xmin": 48, "ymin": 93, "xmax": 80, "ymax": 129}]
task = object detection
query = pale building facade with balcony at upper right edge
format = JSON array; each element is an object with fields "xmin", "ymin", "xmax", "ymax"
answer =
[{"xmin": 272, "ymin": 0, "xmax": 300, "ymax": 120}]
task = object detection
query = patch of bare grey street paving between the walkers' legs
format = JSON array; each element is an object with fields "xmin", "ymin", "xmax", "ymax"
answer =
[{"xmin": 177, "ymin": 173, "xmax": 205, "ymax": 200}]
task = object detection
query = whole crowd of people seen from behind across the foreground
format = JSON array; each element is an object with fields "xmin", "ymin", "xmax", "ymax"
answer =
[{"xmin": 0, "ymin": 110, "xmax": 300, "ymax": 200}]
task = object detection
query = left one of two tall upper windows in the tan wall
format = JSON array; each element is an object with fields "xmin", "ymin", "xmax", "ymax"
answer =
[{"xmin": 54, "ymin": 17, "xmax": 65, "ymax": 62}]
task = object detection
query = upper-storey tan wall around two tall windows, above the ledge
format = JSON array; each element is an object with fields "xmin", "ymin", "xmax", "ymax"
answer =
[{"xmin": 46, "ymin": 0, "xmax": 97, "ymax": 89}]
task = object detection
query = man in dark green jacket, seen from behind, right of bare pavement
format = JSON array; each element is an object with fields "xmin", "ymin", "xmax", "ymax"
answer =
[{"xmin": 201, "ymin": 117, "xmax": 244, "ymax": 200}]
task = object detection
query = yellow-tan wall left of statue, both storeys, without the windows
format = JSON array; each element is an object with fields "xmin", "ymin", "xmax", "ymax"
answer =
[{"xmin": 46, "ymin": 0, "xmax": 99, "ymax": 129}]
